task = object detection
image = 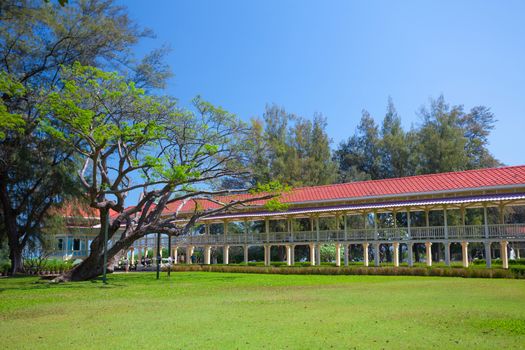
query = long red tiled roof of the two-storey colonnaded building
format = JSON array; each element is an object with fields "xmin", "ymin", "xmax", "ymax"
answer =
[{"xmin": 166, "ymin": 165, "xmax": 525, "ymax": 212}]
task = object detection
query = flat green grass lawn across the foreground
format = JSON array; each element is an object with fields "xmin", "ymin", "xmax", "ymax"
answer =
[{"xmin": 0, "ymin": 272, "xmax": 525, "ymax": 349}]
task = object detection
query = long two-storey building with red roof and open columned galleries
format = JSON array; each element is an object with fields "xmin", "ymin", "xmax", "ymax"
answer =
[{"xmin": 54, "ymin": 166, "xmax": 525, "ymax": 267}]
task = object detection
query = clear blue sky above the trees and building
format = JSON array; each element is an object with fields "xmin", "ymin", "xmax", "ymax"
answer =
[{"xmin": 121, "ymin": 0, "xmax": 525, "ymax": 165}]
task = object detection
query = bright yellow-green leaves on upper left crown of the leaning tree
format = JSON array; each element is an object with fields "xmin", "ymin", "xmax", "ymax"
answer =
[{"xmin": 39, "ymin": 62, "xmax": 165, "ymax": 147}]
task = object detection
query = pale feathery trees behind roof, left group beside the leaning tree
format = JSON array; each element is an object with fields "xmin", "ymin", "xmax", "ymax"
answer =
[{"xmin": 248, "ymin": 105, "xmax": 337, "ymax": 187}]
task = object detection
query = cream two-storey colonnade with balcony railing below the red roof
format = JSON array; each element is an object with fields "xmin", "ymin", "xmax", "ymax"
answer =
[{"xmin": 125, "ymin": 198, "xmax": 525, "ymax": 268}]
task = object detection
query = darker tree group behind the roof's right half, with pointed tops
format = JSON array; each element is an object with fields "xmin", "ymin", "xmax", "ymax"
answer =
[{"xmin": 334, "ymin": 96, "xmax": 499, "ymax": 182}]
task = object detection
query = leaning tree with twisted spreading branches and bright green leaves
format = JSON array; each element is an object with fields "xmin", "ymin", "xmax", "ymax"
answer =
[{"xmin": 42, "ymin": 64, "xmax": 276, "ymax": 280}]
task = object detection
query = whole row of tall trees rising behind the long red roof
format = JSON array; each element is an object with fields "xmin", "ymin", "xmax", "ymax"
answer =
[{"xmin": 248, "ymin": 96, "xmax": 501, "ymax": 186}]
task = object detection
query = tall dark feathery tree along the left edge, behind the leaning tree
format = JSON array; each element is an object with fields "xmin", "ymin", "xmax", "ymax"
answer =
[{"xmin": 0, "ymin": 0, "xmax": 169, "ymax": 273}]
